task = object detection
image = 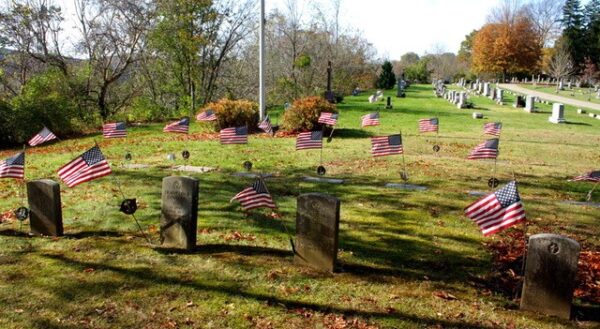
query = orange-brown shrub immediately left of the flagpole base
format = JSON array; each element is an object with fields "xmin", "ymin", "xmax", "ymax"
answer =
[{"xmin": 200, "ymin": 98, "xmax": 258, "ymax": 131}]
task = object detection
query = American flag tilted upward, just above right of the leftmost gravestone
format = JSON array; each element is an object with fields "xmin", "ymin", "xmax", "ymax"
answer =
[{"xmin": 58, "ymin": 146, "xmax": 112, "ymax": 187}]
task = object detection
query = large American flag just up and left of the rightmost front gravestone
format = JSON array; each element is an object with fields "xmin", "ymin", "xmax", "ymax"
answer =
[{"xmin": 465, "ymin": 181, "xmax": 525, "ymax": 236}]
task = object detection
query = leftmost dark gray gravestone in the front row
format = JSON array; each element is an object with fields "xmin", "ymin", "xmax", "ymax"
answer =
[{"xmin": 27, "ymin": 179, "xmax": 63, "ymax": 236}]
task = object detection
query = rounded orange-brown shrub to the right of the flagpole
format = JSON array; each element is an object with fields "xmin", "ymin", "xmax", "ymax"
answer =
[{"xmin": 281, "ymin": 96, "xmax": 338, "ymax": 132}]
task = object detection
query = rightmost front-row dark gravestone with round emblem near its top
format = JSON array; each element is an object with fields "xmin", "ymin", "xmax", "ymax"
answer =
[{"xmin": 521, "ymin": 234, "xmax": 580, "ymax": 319}]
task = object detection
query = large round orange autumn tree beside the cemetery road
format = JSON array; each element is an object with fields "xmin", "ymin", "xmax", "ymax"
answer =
[{"xmin": 472, "ymin": 17, "xmax": 542, "ymax": 79}]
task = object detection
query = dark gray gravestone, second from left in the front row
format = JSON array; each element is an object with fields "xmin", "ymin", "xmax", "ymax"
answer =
[{"xmin": 160, "ymin": 176, "xmax": 198, "ymax": 250}]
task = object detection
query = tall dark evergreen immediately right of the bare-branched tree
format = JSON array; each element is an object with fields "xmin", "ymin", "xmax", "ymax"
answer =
[{"xmin": 561, "ymin": 0, "xmax": 586, "ymax": 67}]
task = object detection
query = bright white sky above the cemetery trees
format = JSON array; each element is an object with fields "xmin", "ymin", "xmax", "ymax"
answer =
[{"xmin": 56, "ymin": 0, "xmax": 501, "ymax": 60}]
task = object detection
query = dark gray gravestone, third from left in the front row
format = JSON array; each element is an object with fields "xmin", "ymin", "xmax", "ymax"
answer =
[{"xmin": 294, "ymin": 193, "xmax": 340, "ymax": 272}]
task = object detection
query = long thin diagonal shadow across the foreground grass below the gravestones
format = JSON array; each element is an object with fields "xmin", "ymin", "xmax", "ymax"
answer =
[{"xmin": 42, "ymin": 254, "xmax": 492, "ymax": 329}]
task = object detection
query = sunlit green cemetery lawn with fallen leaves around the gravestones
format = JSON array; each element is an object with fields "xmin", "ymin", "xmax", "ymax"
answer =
[{"xmin": 0, "ymin": 85, "xmax": 600, "ymax": 328}]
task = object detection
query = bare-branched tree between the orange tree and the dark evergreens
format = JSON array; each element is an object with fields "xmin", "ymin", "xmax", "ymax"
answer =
[{"xmin": 525, "ymin": 0, "xmax": 564, "ymax": 47}]
